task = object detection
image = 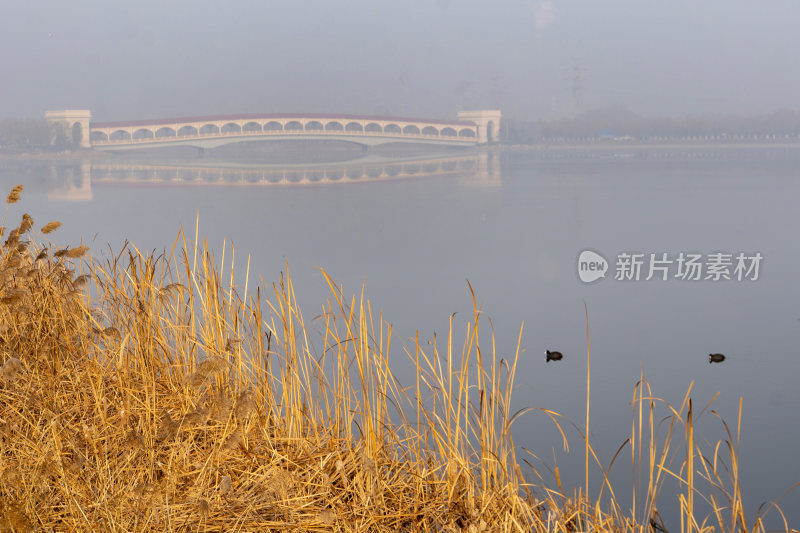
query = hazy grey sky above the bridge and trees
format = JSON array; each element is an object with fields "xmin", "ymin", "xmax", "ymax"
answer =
[{"xmin": 0, "ymin": 0, "xmax": 800, "ymax": 120}]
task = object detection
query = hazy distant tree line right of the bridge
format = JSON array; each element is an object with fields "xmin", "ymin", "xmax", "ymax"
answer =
[{"xmin": 505, "ymin": 107, "xmax": 800, "ymax": 143}]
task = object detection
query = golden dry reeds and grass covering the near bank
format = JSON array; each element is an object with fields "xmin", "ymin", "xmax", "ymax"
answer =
[{"xmin": 0, "ymin": 188, "xmax": 788, "ymax": 532}]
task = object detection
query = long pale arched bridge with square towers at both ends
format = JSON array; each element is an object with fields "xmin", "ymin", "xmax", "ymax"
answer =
[{"xmin": 45, "ymin": 110, "xmax": 501, "ymax": 151}]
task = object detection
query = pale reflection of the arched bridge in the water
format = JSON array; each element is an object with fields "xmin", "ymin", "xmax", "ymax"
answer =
[{"xmin": 48, "ymin": 151, "xmax": 501, "ymax": 201}]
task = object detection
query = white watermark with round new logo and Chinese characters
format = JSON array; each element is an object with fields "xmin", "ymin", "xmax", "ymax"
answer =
[{"xmin": 578, "ymin": 250, "xmax": 764, "ymax": 283}]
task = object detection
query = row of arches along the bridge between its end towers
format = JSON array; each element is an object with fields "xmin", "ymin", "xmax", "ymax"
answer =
[{"xmin": 91, "ymin": 119, "xmax": 477, "ymax": 144}]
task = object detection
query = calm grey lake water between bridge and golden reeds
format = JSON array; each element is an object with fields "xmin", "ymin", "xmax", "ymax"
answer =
[{"xmin": 0, "ymin": 148, "xmax": 800, "ymax": 530}]
